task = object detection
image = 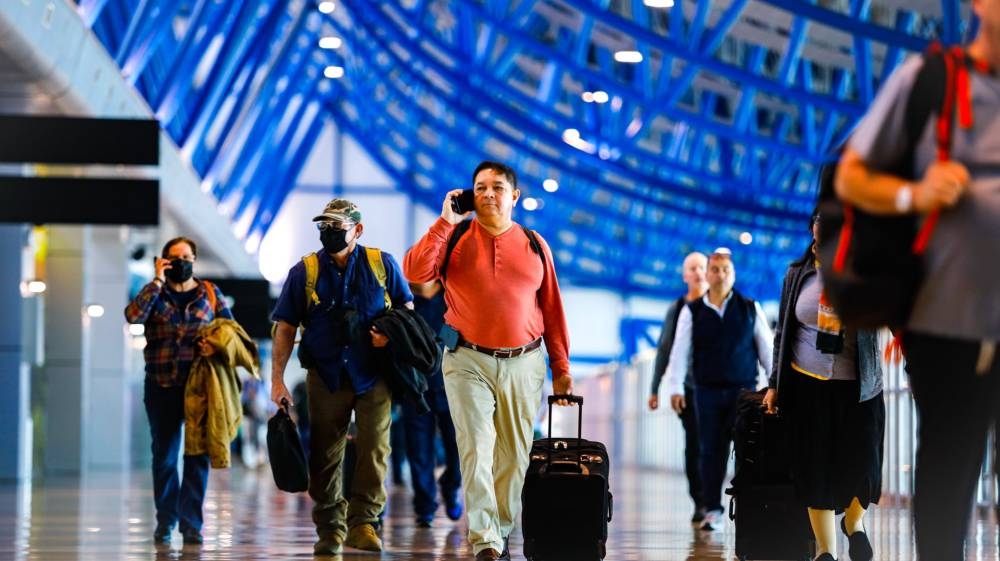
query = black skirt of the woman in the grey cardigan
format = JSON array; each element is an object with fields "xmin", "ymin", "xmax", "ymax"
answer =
[{"xmin": 781, "ymin": 371, "xmax": 885, "ymax": 512}]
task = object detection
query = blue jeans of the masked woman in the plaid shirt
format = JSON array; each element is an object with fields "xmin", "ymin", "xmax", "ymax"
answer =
[{"xmin": 143, "ymin": 380, "xmax": 209, "ymax": 532}]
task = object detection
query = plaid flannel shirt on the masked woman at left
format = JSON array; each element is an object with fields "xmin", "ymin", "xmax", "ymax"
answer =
[{"xmin": 125, "ymin": 282, "xmax": 233, "ymax": 388}]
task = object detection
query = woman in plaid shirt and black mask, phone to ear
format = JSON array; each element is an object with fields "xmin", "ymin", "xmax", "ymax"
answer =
[{"xmin": 125, "ymin": 237, "xmax": 233, "ymax": 544}]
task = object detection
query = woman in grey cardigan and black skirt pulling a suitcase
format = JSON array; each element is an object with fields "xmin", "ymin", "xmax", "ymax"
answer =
[{"xmin": 764, "ymin": 214, "xmax": 885, "ymax": 561}]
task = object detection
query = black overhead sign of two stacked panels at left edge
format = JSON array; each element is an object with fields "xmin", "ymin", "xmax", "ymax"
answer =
[{"xmin": 0, "ymin": 115, "xmax": 160, "ymax": 225}]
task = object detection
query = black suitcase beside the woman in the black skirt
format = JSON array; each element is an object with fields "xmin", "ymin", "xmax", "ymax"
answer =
[{"xmin": 726, "ymin": 391, "xmax": 812, "ymax": 561}]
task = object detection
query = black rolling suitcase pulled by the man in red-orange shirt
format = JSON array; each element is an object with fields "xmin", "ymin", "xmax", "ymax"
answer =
[{"xmin": 521, "ymin": 395, "xmax": 612, "ymax": 561}]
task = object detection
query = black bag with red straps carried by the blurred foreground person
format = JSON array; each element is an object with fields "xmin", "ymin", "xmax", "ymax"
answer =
[{"xmin": 817, "ymin": 45, "xmax": 967, "ymax": 329}]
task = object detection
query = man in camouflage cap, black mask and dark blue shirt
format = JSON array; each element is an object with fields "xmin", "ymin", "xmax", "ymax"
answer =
[{"xmin": 271, "ymin": 198, "xmax": 413, "ymax": 555}]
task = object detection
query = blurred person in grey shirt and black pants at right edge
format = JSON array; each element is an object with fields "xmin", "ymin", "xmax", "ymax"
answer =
[{"xmin": 836, "ymin": 0, "xmax": 1000, "ymax": 561}]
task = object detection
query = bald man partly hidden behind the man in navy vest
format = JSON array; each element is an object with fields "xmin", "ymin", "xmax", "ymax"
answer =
[{"xmin": 649, "ymin": 251, "xmax": 708, "ymax": 526}]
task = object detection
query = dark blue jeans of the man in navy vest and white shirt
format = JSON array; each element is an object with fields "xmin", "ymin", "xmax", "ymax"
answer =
[{"xmin": 694, "ymin": 386, "xmax": 753, "ymax": 510}]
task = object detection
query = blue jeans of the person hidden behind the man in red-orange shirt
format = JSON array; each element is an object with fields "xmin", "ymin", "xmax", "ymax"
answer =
[{"xmin": 403, "ymin": 388, "xmax": 462, "ymax": 519}]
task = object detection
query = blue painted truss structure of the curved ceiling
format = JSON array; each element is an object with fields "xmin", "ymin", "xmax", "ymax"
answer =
[{"xmin": 78, "ymin": 0, "xmax": 975, "ymax": 299}]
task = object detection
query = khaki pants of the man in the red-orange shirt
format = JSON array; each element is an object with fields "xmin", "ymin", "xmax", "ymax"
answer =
[{"xmin": 442, "ymin": 347, "xmax": 545, "ymax": 553}]
